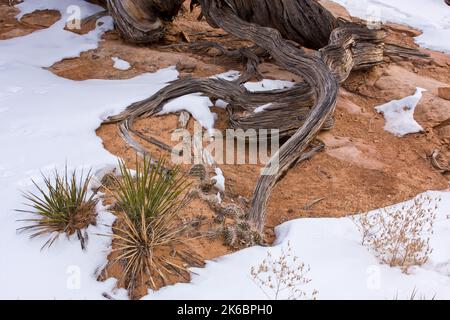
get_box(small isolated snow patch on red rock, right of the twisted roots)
[375,88,426,137]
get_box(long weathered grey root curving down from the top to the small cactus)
[202,1,383,231]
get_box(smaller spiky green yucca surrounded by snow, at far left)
[17,167,98,249]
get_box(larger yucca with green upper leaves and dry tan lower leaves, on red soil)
[111,158,193,291]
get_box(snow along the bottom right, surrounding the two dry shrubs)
[145,192,450,300]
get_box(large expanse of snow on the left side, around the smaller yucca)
[0,0,178,299]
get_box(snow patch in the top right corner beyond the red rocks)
[334,0,450,53]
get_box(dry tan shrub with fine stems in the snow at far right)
[354,195,440,273]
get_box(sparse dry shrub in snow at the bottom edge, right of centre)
[250,243,318,300]
